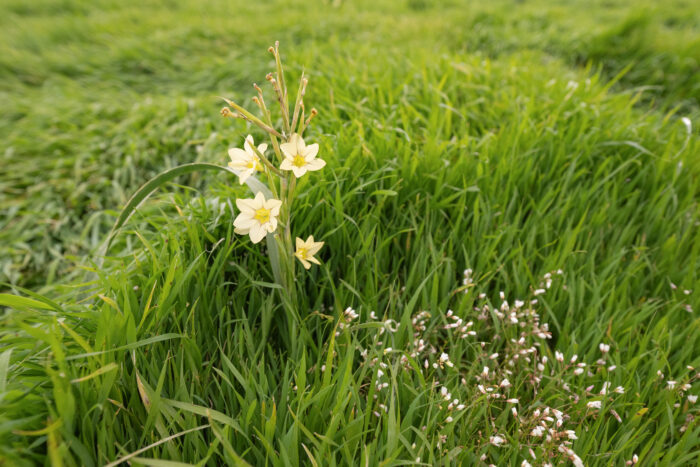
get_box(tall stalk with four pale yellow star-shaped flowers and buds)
[221,43,326,289]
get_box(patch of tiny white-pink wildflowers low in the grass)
[328,270,672,466]
